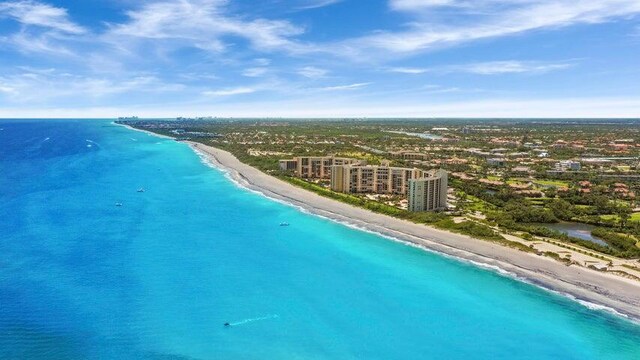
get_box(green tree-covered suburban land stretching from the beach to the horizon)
[122,119,640,258]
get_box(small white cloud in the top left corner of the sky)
[0,0,86,34]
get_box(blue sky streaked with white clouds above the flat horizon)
[0,0,640,117]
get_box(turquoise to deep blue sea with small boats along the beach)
[0,121,640,359]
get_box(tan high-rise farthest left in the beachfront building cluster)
[280,156,366,179]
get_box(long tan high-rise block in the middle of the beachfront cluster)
[331,164,424,195]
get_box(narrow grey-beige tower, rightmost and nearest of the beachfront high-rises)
[407,170,448,211]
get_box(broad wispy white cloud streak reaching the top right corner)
[344,0,640,56]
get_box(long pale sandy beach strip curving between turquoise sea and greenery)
[187,142,640,320]
